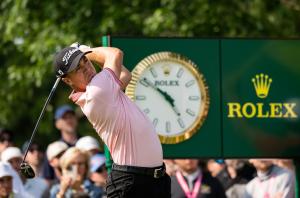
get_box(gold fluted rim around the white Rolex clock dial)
[126,51,210,144]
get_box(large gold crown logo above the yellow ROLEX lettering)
[252,74,272,98]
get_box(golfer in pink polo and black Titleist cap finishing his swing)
[54,44,171,198]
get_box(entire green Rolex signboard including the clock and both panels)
[111,38,300,158]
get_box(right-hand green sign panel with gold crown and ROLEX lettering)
[221,39,300,157]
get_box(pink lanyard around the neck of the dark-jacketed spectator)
[176,171,202,198]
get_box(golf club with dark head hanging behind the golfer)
[20,77,61,178]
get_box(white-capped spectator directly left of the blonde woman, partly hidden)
[46,141,68,186]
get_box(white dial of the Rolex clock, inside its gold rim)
[135,61,202,136]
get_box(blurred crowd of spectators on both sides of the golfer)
[0,105,296,198]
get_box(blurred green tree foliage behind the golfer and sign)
[0,0,300,145]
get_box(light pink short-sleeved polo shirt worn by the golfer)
[70,68,163,167]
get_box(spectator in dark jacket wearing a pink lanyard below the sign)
[171,159,226,198]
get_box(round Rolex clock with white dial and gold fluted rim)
[126,52,209,144]
